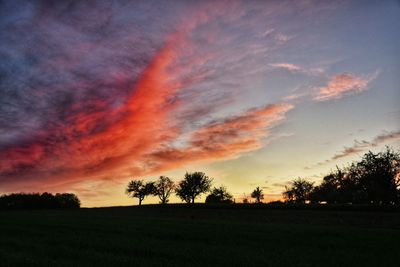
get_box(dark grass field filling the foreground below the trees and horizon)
[0,205,400,267]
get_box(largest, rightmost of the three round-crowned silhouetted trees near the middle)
[175,172,212,203]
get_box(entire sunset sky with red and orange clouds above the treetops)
[0,0,400,207]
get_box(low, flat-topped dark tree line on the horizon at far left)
[0,192,81,209]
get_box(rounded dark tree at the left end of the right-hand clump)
[283,178,314,203]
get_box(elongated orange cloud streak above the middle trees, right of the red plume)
[148,104,293,171]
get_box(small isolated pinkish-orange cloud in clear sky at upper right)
[313,72,378,101]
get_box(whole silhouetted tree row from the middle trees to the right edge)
[126,147,400,205]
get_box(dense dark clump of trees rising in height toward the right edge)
[283,147,400,205]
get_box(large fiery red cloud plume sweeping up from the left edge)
[0,46,179,189]
